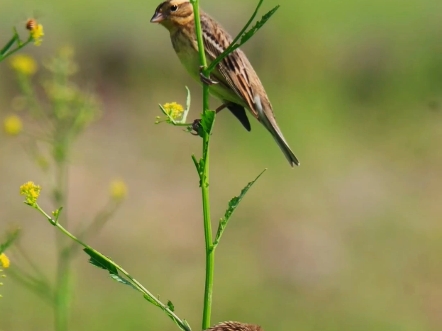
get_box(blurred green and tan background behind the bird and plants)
[0,0,442,331]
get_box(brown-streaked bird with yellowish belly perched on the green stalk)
[150,0,299,167]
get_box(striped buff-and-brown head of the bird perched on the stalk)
[150,0,193,30]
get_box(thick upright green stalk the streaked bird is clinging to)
[191,0,215,330]
